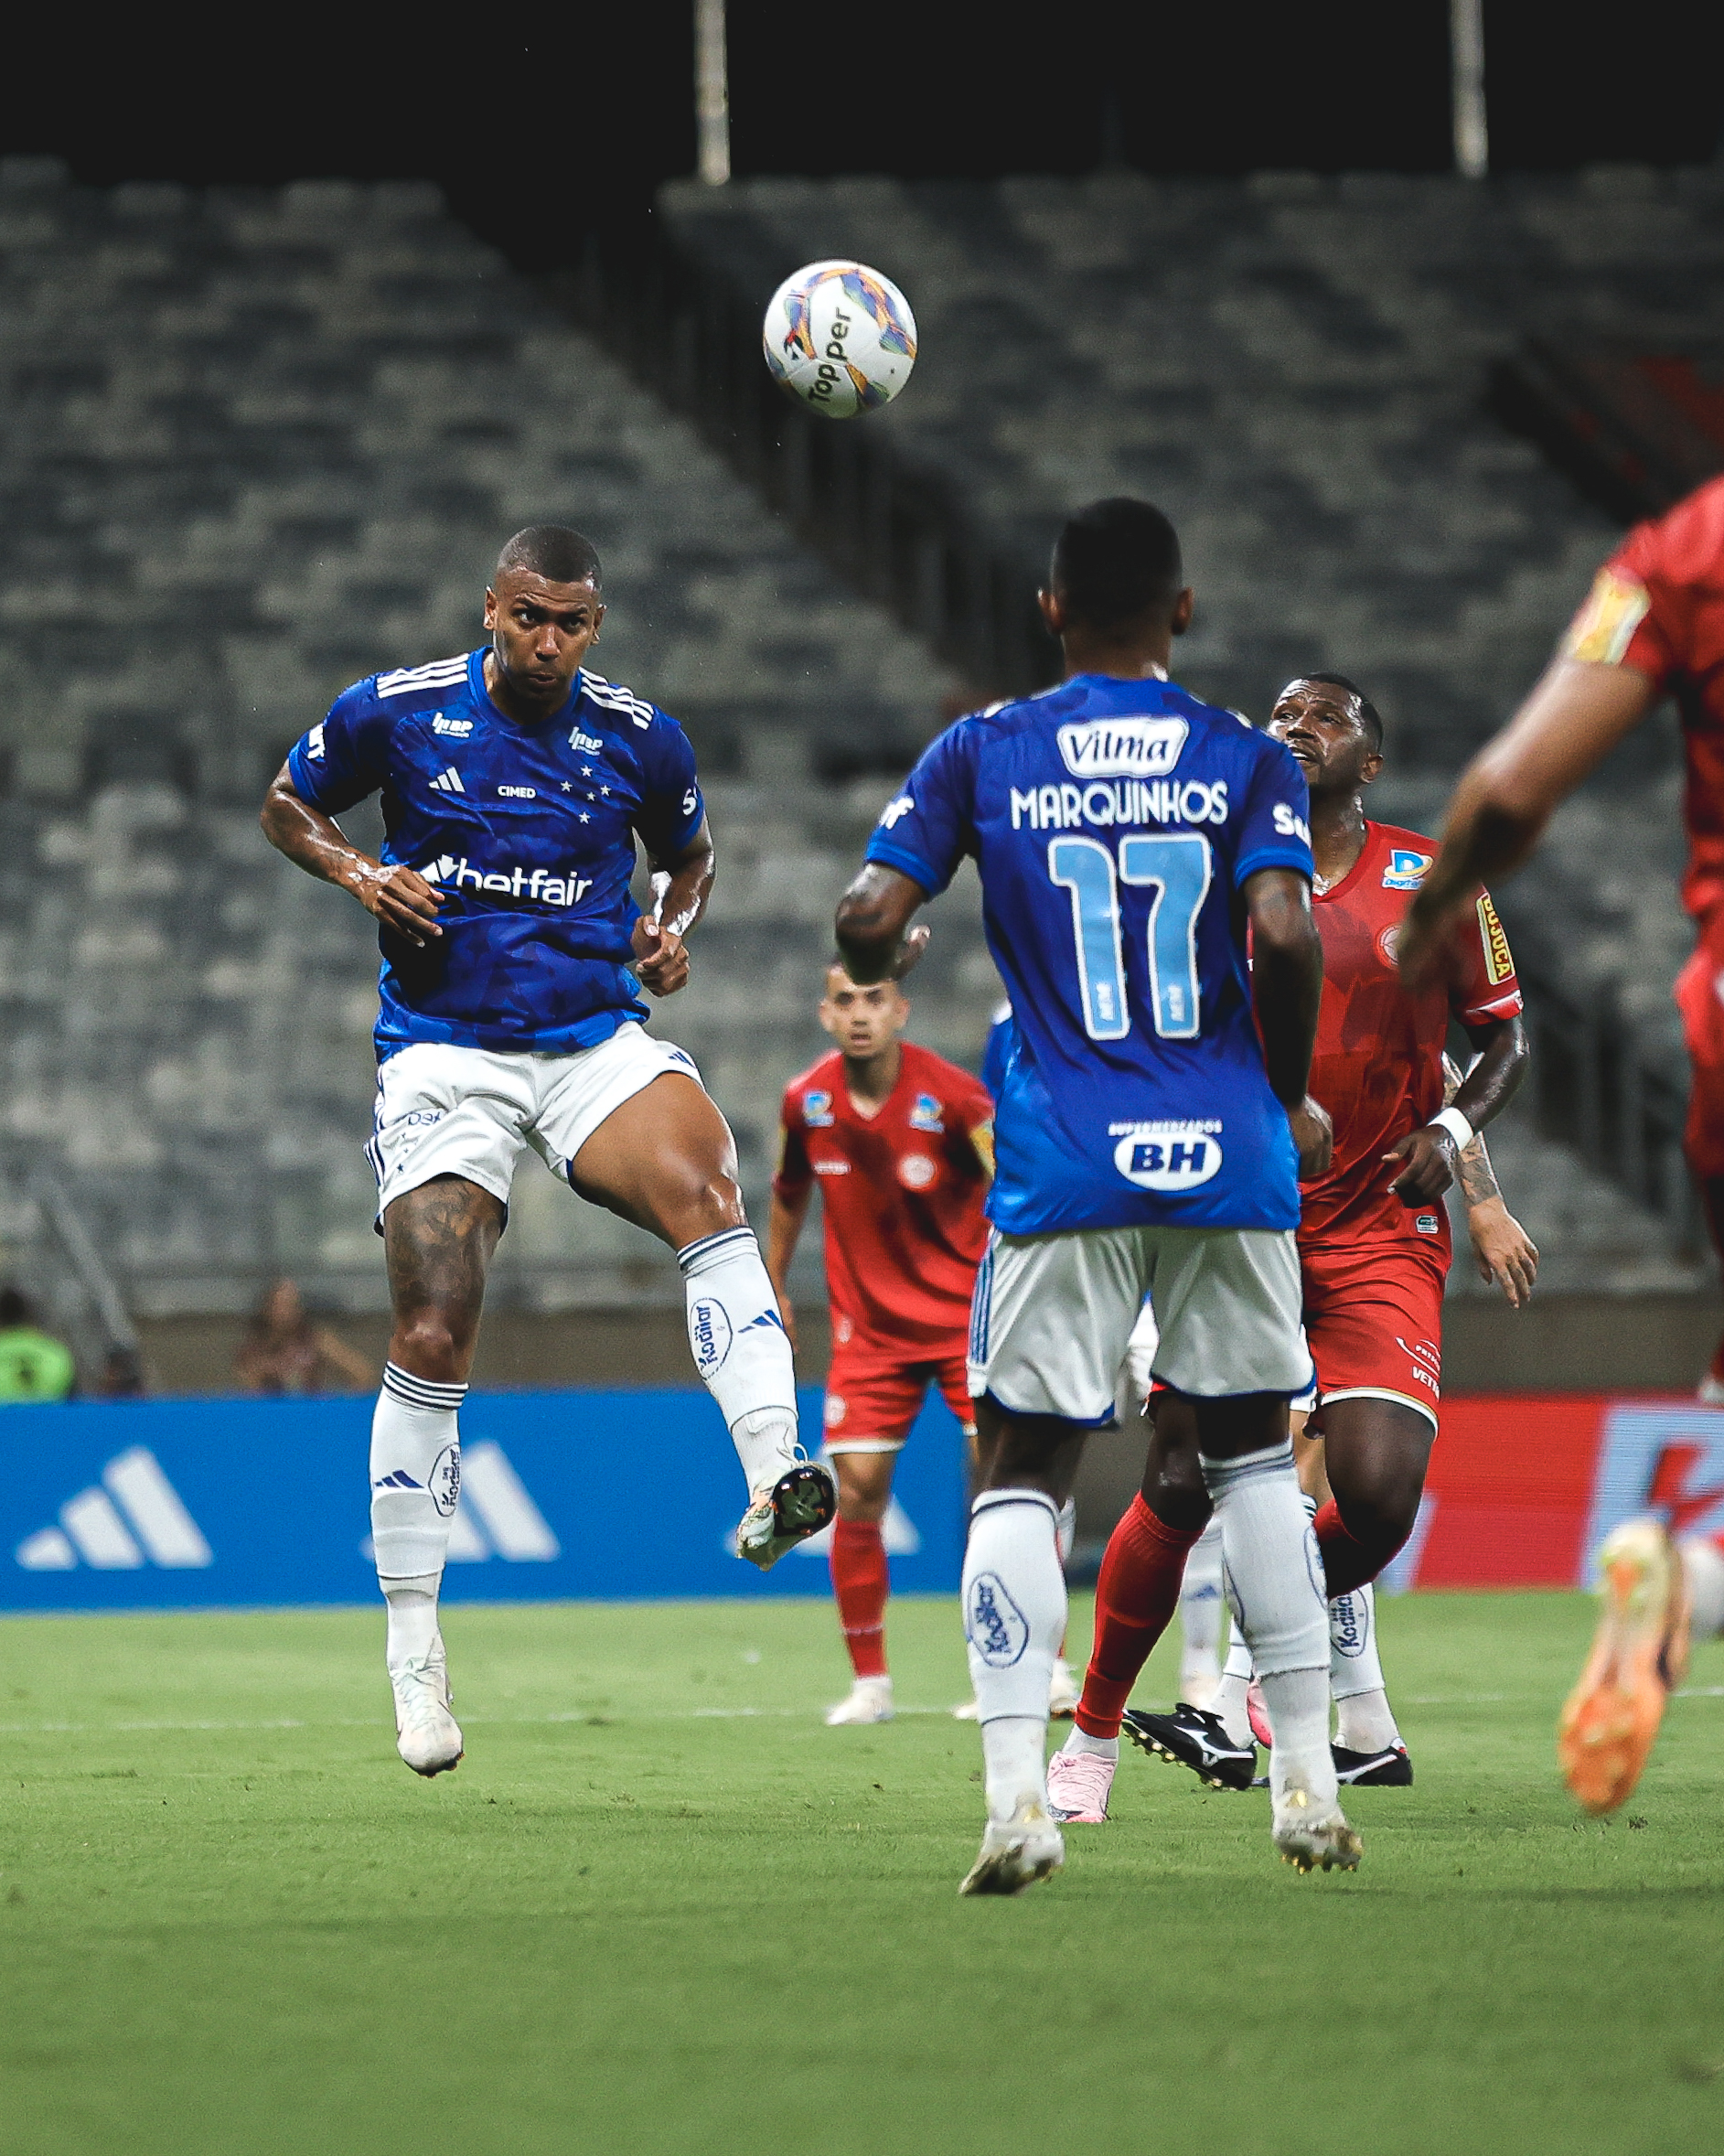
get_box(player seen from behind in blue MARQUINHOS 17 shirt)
[839,500,1360,1893]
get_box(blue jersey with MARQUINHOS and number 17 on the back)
[869,675,1312,1236]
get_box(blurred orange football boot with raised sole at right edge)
[1556,1520,1687,1818]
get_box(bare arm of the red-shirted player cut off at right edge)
[1398,660,1655,990]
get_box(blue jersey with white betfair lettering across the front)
[286,649,704,1061]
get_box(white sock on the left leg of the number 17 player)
[963,1490,1066,1819]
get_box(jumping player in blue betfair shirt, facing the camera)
[262,524,839,1775]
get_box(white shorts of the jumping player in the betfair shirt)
[364,1020,701,1220]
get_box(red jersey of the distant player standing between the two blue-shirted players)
[772,1041,993,1347]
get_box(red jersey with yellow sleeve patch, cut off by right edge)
[1562,478,1724,920]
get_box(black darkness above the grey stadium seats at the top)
[0,0,1724,265]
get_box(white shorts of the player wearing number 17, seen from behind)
[969,1227,1314,1430]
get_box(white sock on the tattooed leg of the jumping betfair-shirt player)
[370,1363,467,1667]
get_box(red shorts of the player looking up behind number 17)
[1300,1242,1444,1425]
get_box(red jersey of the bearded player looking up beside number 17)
[1300,823,1522,1263]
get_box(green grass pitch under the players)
[0,1595,1724,2156]
